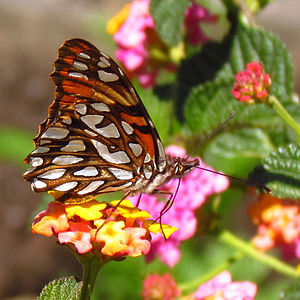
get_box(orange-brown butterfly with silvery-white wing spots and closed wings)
[23,39,200,203]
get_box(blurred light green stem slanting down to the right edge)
[219,230,300,278]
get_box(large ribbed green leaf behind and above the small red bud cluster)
[218,24,294,101]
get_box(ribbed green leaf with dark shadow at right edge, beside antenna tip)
[250,144,300,199]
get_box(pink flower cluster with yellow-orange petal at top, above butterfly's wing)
[108,0,161,88]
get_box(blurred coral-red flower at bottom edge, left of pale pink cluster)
[143,273,180,300]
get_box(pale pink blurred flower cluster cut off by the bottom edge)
[194,271,257,300]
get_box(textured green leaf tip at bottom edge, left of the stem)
[37,276,82,300]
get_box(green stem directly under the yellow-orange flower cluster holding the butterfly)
[80,260,101,300]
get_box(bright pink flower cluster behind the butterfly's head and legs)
[128,146,229,267]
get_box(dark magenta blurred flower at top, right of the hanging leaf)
[184,2,219,46]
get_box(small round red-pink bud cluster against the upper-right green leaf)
[232,61,271,104]
